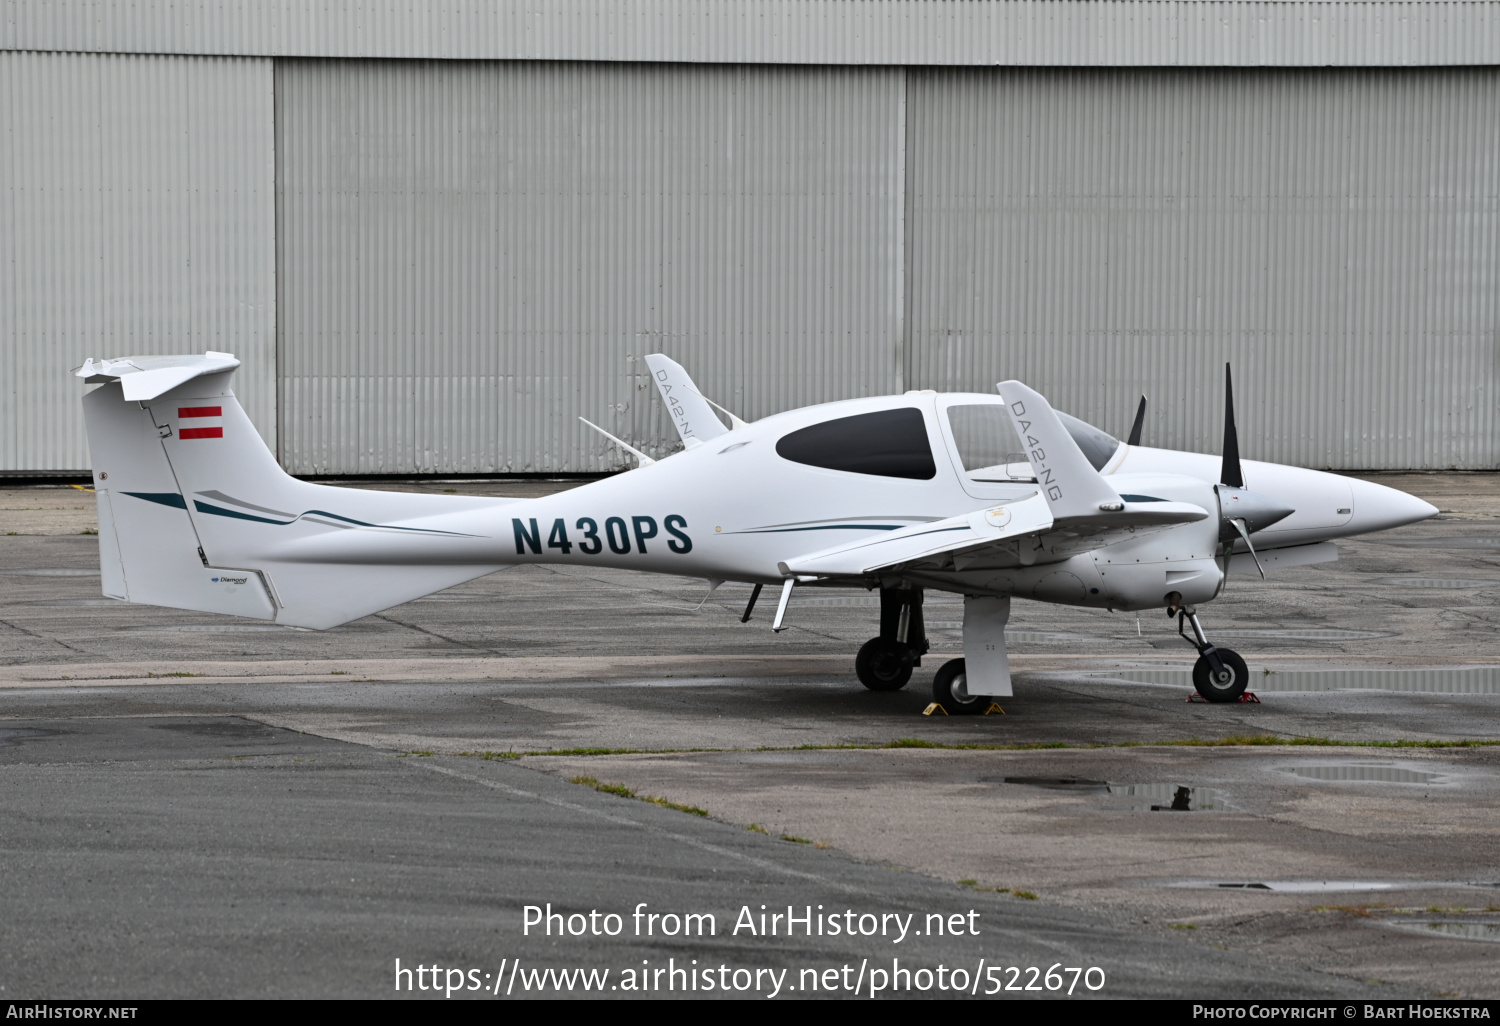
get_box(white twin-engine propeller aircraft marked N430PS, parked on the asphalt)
[78,353,1437,713]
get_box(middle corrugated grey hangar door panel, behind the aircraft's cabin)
[276,62,905,474]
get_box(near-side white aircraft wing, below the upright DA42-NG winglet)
[782,494,1209,578]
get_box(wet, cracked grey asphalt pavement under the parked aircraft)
[0,476,1500,999]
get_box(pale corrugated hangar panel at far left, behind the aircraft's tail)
[0,53,276,473]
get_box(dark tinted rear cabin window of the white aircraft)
[776,407,938,482]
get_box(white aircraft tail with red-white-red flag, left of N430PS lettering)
[78,353,515,630]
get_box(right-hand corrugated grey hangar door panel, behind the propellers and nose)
[906,69,1500,468]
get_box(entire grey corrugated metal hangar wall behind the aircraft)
[0,0,1500,474]
